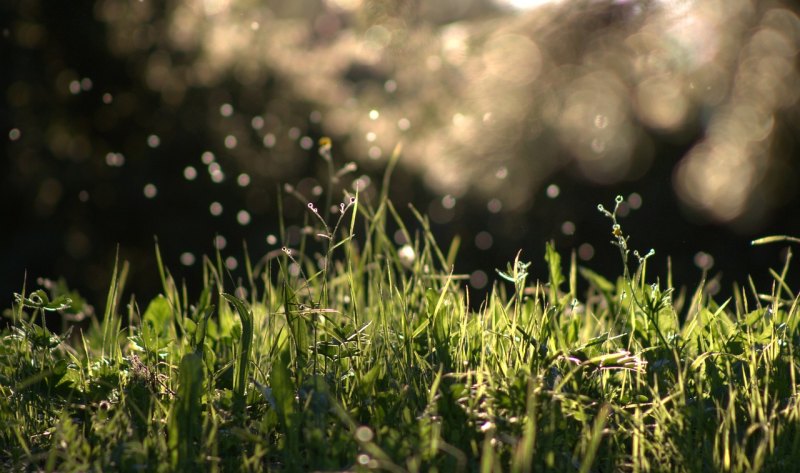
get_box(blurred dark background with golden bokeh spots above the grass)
[0,0,800,307]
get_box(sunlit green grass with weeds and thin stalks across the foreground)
[0,145,800,473]
